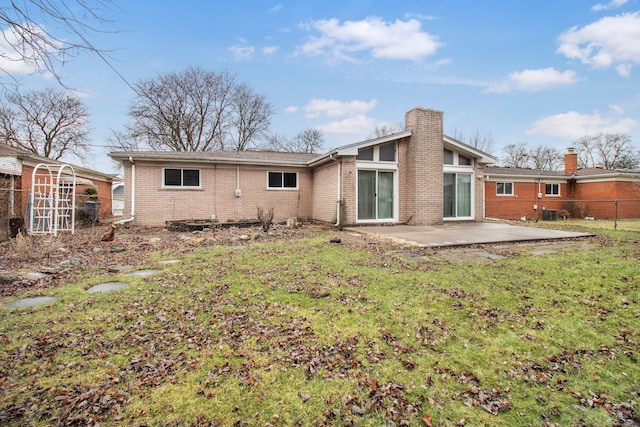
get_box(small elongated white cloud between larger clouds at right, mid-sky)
[487,68,577,93]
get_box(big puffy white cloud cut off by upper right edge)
[558,12,640,77]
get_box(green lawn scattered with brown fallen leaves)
[0,221,640,426]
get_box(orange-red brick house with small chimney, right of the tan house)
[485,148,640,220]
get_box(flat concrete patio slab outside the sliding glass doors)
[348,222,593,247]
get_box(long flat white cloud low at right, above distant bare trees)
[527,111,640,139]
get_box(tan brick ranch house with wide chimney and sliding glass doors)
[109,107,495,226]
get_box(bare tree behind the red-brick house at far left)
[0,89,90,160]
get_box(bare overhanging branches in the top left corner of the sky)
[0,0,114,86]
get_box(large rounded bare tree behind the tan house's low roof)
[126,67,273,151]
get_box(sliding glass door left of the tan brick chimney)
[358,170,394,220]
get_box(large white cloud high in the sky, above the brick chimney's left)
[297,17,443,61]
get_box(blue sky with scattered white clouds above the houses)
[0,0,640,173]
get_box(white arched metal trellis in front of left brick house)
[28,163,76,236]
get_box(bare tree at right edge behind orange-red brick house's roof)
[574,133,640,170]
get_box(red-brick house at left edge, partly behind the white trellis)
[0,144,113,240]
